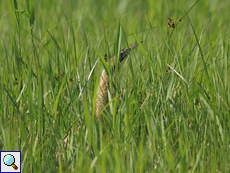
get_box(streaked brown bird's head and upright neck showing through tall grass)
[95,44,141,118]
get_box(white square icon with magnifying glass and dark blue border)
[0,151,21,173]
